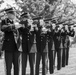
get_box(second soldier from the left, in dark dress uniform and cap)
[19,13,36,75]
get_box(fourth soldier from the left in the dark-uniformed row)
[47,23,56,74]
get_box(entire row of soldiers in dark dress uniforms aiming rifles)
[1,9,75,75]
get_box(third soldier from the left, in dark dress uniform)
[35,19,48,75]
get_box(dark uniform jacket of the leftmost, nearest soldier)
[1,18,18,51]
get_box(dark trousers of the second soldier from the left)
[22,52,35,75]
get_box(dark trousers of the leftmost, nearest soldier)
[5,51,20,75]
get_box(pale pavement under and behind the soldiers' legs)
[0,48,76,75]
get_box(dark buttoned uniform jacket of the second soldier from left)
[19,22,37,53]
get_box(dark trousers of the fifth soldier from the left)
[54,48,61,70]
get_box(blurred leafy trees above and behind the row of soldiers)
[0,0,76,44]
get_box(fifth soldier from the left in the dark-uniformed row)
[54,23,61,70]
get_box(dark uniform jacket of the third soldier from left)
[36,30,48,53]
